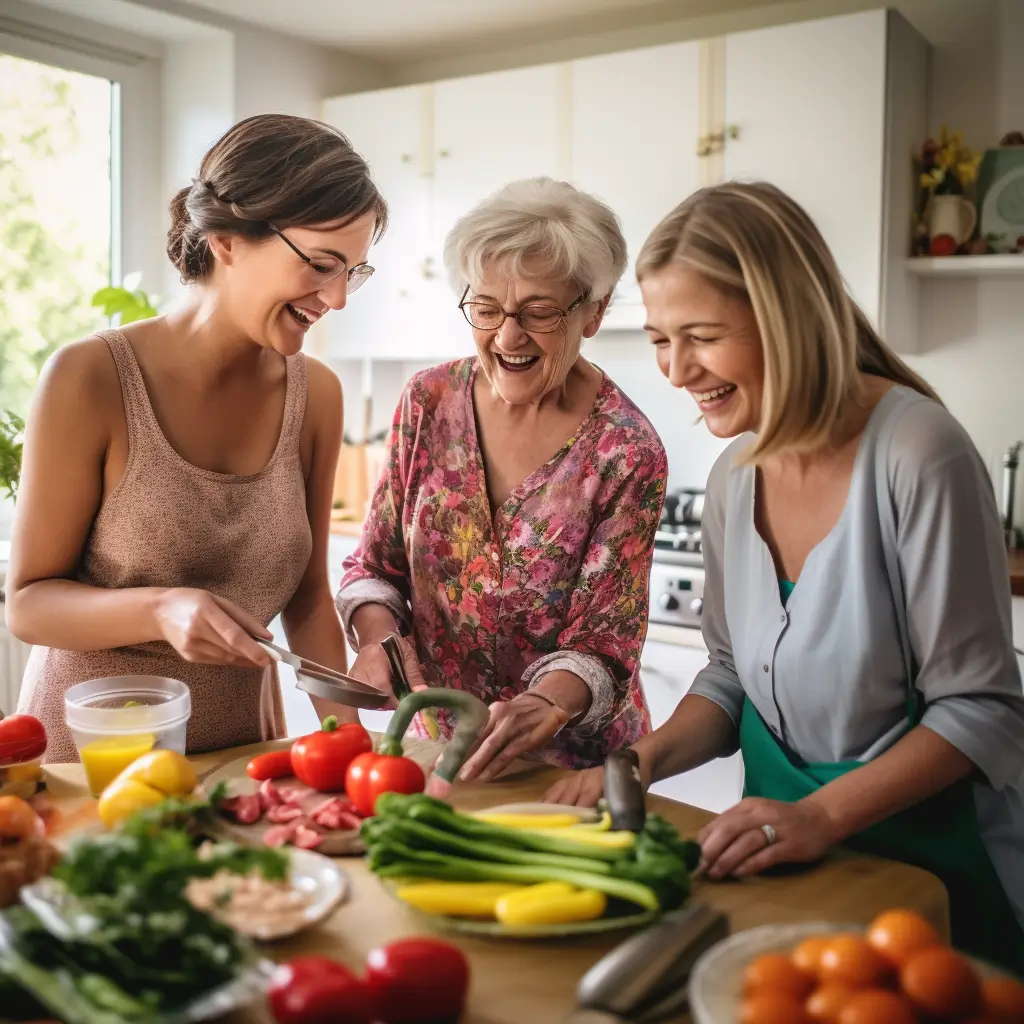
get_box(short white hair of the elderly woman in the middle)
[444,178,627,299]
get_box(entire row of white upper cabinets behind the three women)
[322,10,928,361]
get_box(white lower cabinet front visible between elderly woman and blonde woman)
[640,640,743,813]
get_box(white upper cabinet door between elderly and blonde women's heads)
[571,42,700,329]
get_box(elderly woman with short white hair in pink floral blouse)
[337,178,667,778]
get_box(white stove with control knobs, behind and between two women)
[650,487,705,629]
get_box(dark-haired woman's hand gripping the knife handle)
[156,587,273,669]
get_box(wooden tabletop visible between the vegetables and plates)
[41,744,949,1024]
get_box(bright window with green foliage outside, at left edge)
[0,54,116,416]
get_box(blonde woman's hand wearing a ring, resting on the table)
[697,797,837,880]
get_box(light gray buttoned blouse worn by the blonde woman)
[690,387,1024,927]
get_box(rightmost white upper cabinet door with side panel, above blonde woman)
[723,10,928,350]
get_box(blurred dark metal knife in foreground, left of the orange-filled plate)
[573,903,729,1024]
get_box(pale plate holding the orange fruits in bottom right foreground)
[689,921,1001,1024]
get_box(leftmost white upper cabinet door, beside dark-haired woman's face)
[323,86,431,358]
